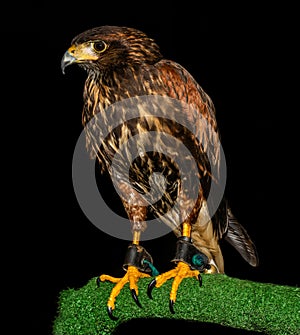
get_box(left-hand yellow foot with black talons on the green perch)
[97,266,150,320]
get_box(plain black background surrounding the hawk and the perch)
[1,1,299,334]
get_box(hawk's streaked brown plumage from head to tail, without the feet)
[62,26,258,315]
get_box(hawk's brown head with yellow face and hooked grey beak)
[61,26,162,73]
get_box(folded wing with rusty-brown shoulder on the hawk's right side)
[156,60,228,238]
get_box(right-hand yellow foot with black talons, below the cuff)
[147,262,202,314]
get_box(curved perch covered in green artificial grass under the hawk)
[53,274,300,335]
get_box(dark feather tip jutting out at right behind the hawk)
[224,208,258,266]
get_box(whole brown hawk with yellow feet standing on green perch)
[61,26,258,319]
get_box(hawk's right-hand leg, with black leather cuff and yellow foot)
[148,223,210,314]
